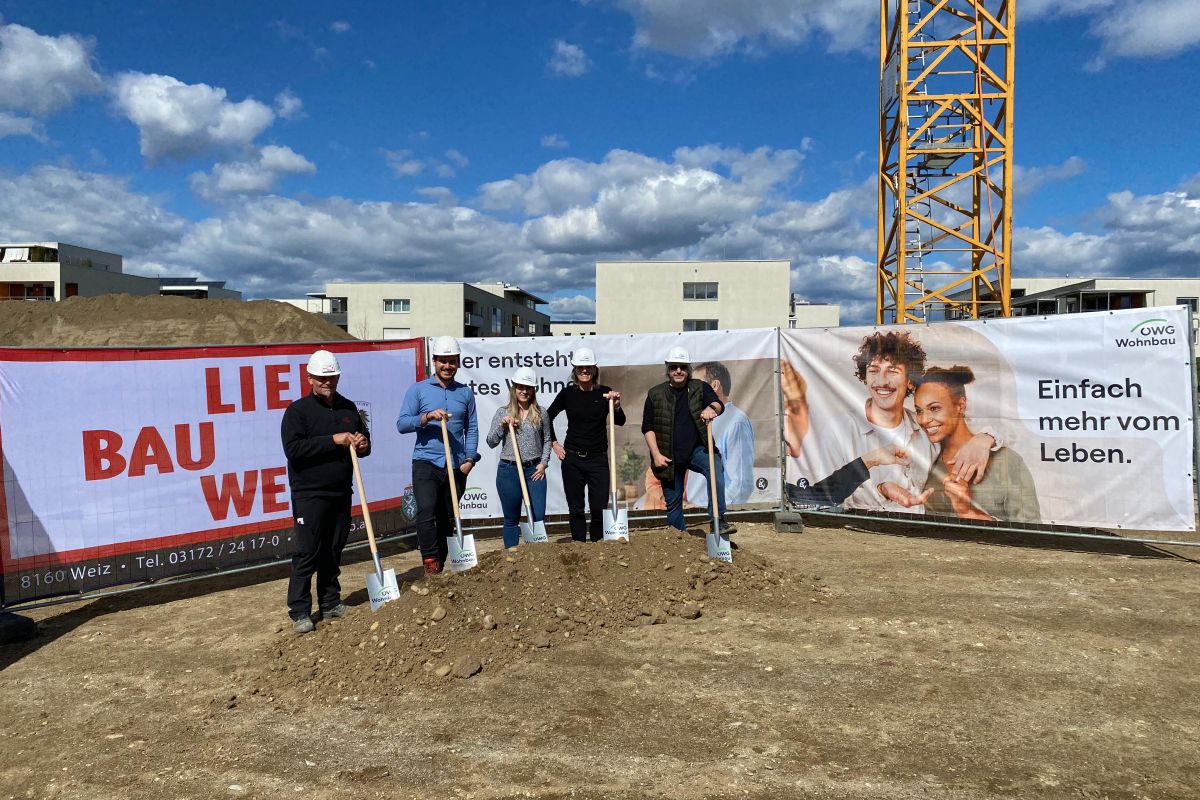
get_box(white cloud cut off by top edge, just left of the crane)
[618,0,880,59]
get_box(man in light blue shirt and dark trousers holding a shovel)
[396,336,479,575]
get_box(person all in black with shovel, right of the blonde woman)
[547,348,625,542]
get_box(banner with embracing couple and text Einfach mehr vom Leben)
[780,307,1195,531]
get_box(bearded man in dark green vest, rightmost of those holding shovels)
[642,347,737,536]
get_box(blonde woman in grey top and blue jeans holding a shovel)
[487,367,551,547]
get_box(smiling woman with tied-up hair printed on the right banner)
[913,365,1042,522]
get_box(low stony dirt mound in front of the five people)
[254,529,817,699]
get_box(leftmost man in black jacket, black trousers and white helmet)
[281,350,371,633]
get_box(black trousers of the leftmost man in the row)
[288,494,350,620]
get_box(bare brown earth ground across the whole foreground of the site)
[0,524,1200,799]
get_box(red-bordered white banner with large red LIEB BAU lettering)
[0,339,422,603]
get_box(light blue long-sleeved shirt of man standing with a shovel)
[396,377,479,469]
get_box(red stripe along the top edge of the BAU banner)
[0,339,425,362]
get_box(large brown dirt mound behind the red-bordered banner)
[0,294,354,347]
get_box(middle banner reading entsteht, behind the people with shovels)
[457,327,780,518]
